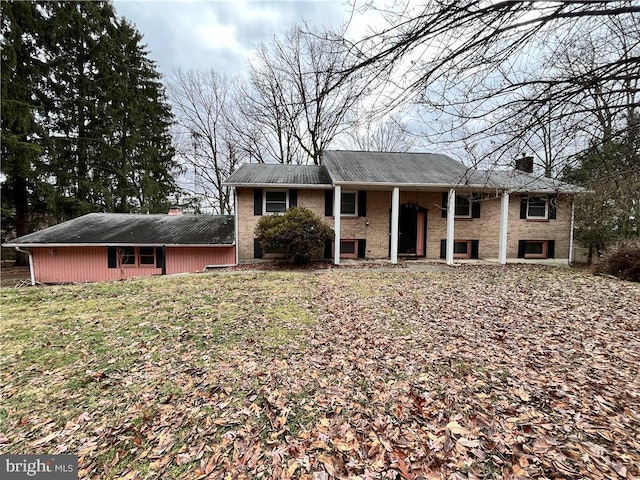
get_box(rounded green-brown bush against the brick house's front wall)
[255,207,334,264]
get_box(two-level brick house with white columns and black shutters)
[226,151,584,264]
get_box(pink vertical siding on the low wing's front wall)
[30,246,235,283]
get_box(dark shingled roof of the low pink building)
[5,213,235,247]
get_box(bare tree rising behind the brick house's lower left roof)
[242,28,362,165]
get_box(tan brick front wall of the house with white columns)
[236,188,572,263]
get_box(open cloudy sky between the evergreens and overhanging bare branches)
[113,0,372,75]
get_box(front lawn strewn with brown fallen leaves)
[0,266,640,479]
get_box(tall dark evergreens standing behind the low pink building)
[2,1,178,248]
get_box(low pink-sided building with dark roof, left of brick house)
[3,209,236,284]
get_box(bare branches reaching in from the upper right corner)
[336,0,640,169]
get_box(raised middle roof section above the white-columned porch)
[322,150,468,186]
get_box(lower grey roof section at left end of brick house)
[224,163,331,188]
